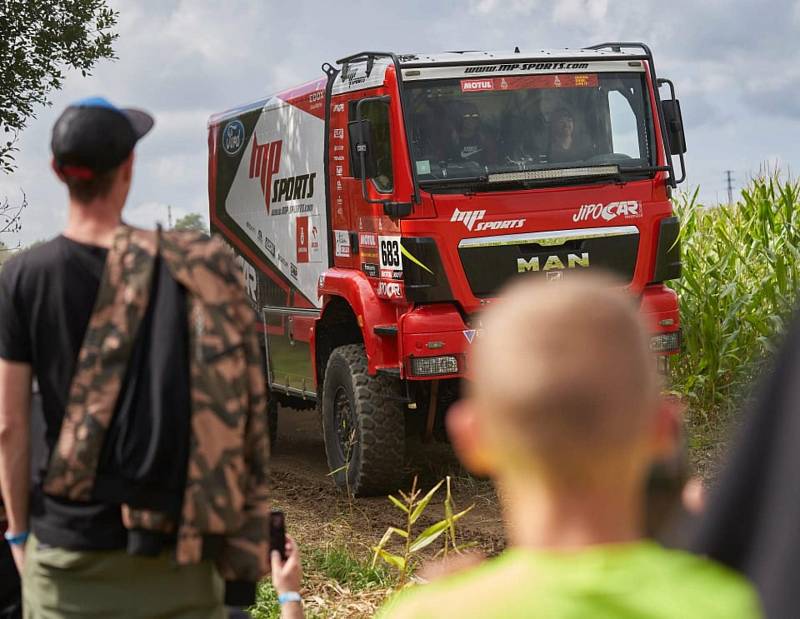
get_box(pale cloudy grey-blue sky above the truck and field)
[0,0,800,245]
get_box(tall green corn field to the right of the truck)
[673,175,800,427]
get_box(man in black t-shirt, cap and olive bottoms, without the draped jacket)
[0,98,224,617]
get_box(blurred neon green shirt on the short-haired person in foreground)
[380,541,761,619]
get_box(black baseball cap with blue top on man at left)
[50,97,155,180]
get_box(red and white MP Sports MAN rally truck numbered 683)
[208,43,686,495]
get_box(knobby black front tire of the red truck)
[322,344,405,496]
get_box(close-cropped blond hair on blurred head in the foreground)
[470,274,659,483]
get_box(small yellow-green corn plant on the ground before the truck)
[372,477,475,587]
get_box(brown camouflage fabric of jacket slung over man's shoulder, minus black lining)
[44,225,269,582]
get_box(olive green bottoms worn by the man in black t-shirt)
[22,536,226,619]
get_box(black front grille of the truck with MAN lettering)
[458,226,639,297]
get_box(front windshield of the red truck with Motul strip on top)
[406,72,655,184]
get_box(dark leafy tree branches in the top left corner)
[0,0,118,172]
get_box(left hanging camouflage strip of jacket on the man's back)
[44,225,159,501]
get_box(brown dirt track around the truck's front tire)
[272,409,504,554]
